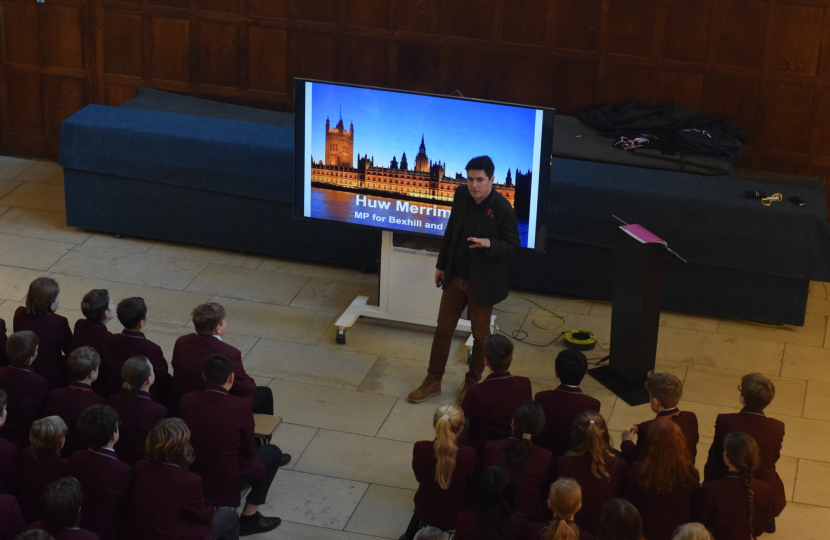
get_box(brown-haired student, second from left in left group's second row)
[43,346,106,458]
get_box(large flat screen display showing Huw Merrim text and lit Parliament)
[295,80,554,250]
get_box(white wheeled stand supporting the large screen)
[334,231,496,356]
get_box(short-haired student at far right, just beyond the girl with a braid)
[703,373,787,533]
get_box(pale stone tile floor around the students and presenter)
[0,157,830,540]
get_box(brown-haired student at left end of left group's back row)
[14,278,72,388]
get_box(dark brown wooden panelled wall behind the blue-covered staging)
[0,0,830,181]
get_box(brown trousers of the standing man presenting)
[427,277,493,383]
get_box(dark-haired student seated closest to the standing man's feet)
[461,334,533,452]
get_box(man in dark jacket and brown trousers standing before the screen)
[409,156,521,403]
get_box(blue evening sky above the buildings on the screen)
[311,83,536,183]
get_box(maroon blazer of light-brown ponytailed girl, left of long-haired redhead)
[556,454,628,535]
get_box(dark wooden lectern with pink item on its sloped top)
[588,225,667,406]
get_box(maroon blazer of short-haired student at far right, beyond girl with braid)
[703,409,787,515]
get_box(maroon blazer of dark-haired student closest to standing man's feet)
[461,371,533,453]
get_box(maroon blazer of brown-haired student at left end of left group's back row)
[14,306,72,388]
